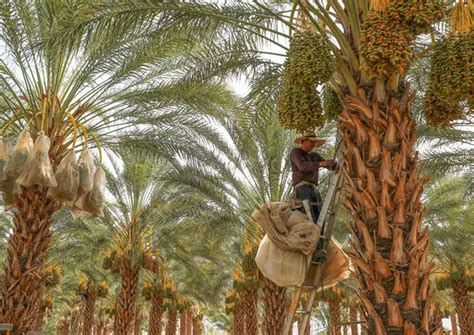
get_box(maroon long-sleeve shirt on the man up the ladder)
[290,148,324,186]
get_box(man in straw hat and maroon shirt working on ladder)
[290,131,336,222]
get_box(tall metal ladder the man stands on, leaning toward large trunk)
[282,171,343,335]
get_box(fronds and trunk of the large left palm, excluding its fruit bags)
[0,0,237,333]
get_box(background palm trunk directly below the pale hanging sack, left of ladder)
[262,278,290,335]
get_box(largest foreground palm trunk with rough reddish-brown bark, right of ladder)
[339,82,434,335]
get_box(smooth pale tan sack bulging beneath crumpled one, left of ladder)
[255,235,308,287]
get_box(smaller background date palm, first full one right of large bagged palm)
[104,151,171,334]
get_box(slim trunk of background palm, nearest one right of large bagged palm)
[114,257,140,335]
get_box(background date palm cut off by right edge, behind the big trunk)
[426,174,474,334]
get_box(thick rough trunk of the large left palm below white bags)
[0,186,60,334]
